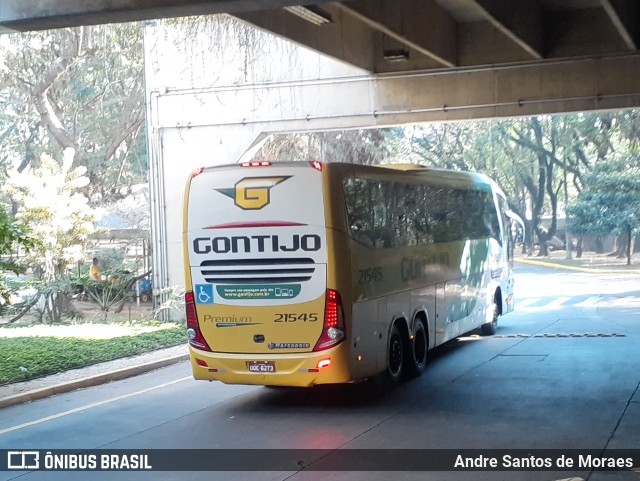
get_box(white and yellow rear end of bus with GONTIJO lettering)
[183,162,349,386]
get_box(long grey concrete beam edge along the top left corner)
[0,0,324,33]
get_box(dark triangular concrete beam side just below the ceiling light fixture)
[234,4,376,72]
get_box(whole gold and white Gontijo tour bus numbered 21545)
[183,161,522,386]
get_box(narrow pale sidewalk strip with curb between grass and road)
[0,343,189,409]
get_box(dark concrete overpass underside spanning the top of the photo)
[0,0,640,120]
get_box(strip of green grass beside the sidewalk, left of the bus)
[0,325,186,385]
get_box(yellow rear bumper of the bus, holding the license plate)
[189,342,351,387]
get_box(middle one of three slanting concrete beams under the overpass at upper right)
[476,0,544,60]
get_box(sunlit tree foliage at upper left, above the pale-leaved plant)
[0,24,147,200]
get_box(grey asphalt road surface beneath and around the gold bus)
[0,266,640,481]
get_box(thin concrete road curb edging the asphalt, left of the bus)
[0,354,189,409]
